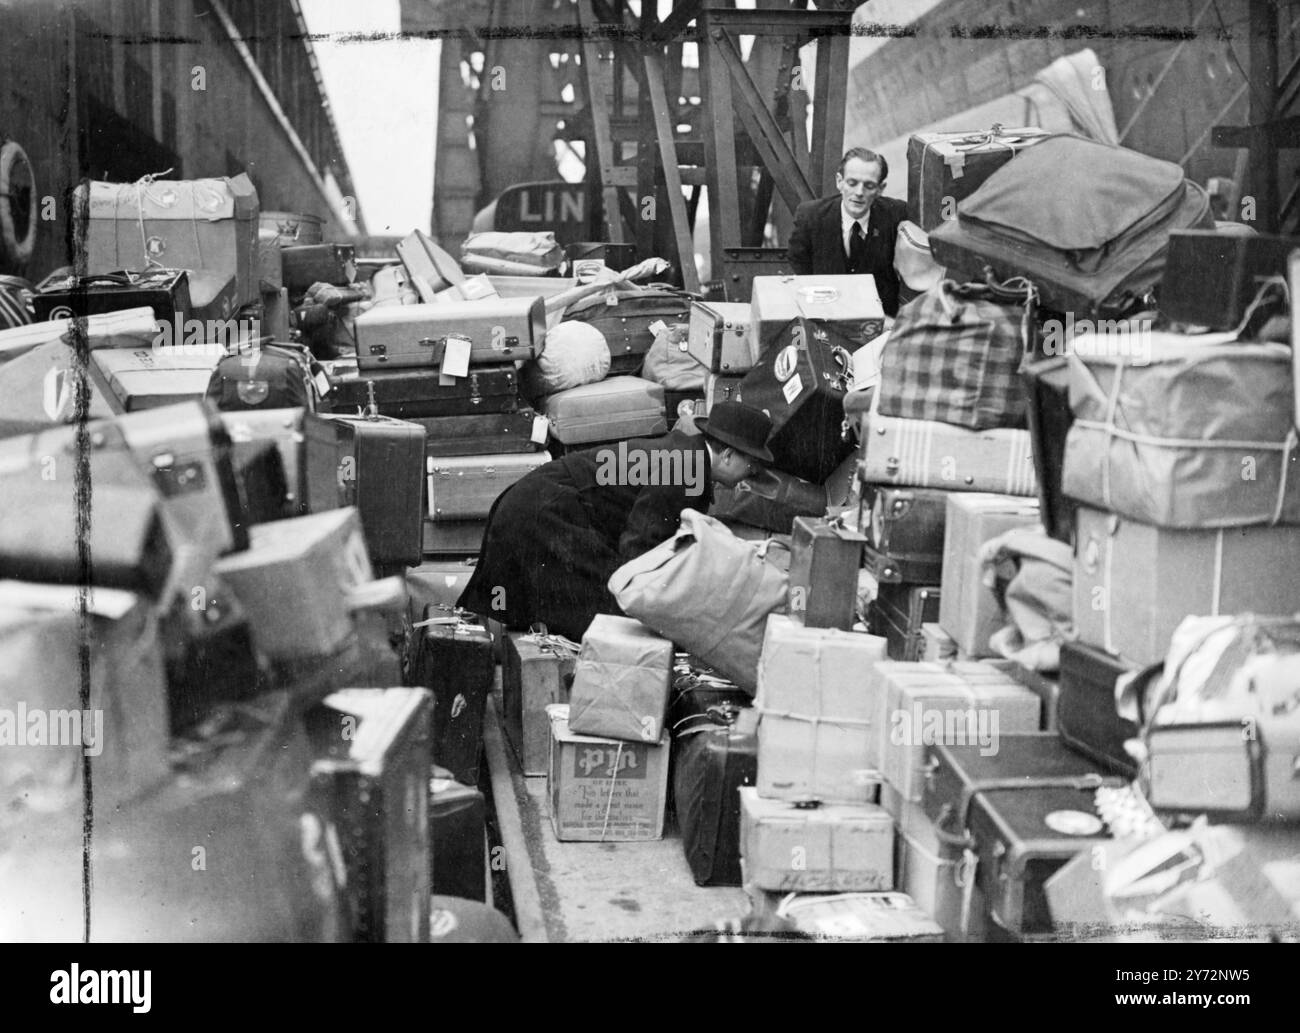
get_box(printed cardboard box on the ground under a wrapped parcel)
[546,703,668,843]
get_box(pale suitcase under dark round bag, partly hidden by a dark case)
[221,409,341,516]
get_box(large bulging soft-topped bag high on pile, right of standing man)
[930,134,1214,317]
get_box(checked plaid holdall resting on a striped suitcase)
[879,279,1034,430]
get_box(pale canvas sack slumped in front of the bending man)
[608,509,789,695]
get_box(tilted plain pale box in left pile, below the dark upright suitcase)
[215,507,373,660]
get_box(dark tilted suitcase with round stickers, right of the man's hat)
[736,320,855,485]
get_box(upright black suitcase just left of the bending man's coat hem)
[411,606,497,786]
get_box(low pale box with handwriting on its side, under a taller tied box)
[740,786,894,893]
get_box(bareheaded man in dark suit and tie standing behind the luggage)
[788,147,907,316]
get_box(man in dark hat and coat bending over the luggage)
[458,402,772,641]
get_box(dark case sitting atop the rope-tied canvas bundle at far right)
[1157,230,1300,330]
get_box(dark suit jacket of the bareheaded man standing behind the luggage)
[787,194,907,316]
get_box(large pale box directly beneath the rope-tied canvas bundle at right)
[1074,505,1300,667]
